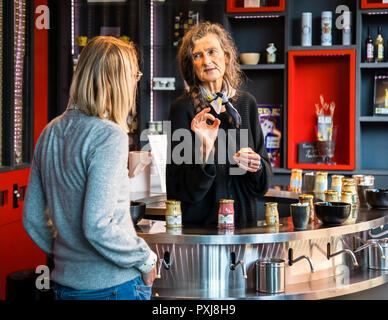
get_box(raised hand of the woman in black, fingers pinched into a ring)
[191,108,221,161]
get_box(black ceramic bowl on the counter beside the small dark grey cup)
[314,202,351,225]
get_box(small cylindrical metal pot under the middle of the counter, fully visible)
[256,258,286,294]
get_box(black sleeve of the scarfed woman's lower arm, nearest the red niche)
[242,95,272,197]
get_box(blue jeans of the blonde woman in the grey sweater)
[54,277,152,300]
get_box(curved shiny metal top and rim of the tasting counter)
[136,209,388,245]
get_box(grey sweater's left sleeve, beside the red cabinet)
[23,142,53,254]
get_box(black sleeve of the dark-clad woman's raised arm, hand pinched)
[166,98,216,203]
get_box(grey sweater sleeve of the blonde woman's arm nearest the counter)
[82,132,156,273]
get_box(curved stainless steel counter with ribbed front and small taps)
[132,190,388,300]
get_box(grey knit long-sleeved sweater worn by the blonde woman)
[23,110,156,290]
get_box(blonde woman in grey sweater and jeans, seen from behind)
[23,37,156,300]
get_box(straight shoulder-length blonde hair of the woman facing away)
[68,36,139,132]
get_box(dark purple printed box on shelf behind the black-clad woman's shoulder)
[257,104,282,168]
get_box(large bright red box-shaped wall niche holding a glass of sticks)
[288,50,356,170]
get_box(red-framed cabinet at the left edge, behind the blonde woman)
[0,0,48,300]
